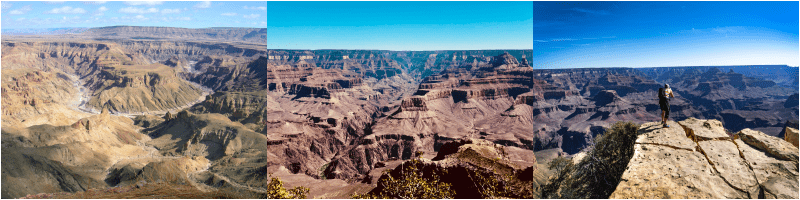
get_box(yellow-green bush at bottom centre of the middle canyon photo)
[352,159,455,199]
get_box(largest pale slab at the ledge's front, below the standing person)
[609,144,748,199]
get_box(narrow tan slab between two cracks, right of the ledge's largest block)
[698,140,758,195]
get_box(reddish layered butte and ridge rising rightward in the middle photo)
[316,54,533,178]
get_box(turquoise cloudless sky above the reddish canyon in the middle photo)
[267,2,533,50]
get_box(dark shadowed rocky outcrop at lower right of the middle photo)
[370,139,536,198]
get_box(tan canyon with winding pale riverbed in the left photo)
[2,27,267,198]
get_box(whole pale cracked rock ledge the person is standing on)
[610,118,798,199]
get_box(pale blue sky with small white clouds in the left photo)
[2,1,267,29]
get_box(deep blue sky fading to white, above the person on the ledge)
[532,2,799,68]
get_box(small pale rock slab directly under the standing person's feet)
[636,121,697,150]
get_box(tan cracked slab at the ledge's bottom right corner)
[736,139,800,199]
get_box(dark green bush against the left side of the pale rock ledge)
[542,122,639,199]
